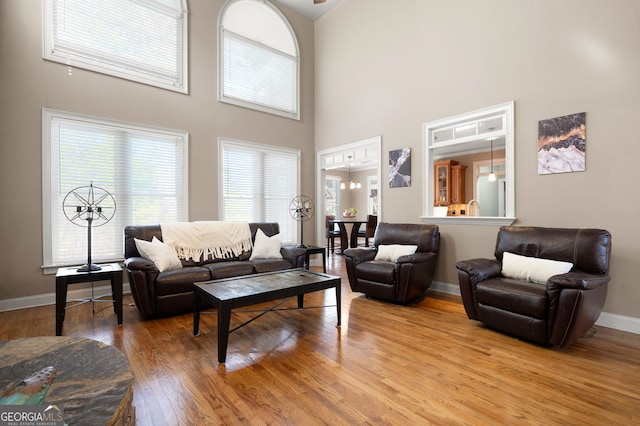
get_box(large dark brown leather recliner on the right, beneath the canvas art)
[456,226,611,347]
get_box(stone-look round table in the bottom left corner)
[0,336,135,425]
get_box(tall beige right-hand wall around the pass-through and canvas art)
[315,0,640,318]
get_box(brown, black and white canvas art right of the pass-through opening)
[538,112,587,175]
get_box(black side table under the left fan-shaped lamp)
[56,263,122,336]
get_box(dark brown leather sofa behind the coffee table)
[124,222,305,317]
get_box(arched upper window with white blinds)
[218,0,300,119]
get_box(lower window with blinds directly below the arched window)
[219,139,300,244]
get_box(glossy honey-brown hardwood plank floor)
[0,255,640,425]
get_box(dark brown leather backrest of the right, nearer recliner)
[494,226,611,274]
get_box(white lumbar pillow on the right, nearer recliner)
[502,252,573,284]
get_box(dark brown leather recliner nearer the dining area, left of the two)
[344,222,440,303]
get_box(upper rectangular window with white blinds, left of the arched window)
[42,0,188,93]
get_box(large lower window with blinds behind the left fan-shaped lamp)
[42,109,188,267]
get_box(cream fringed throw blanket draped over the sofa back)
[160,221,252,262]
